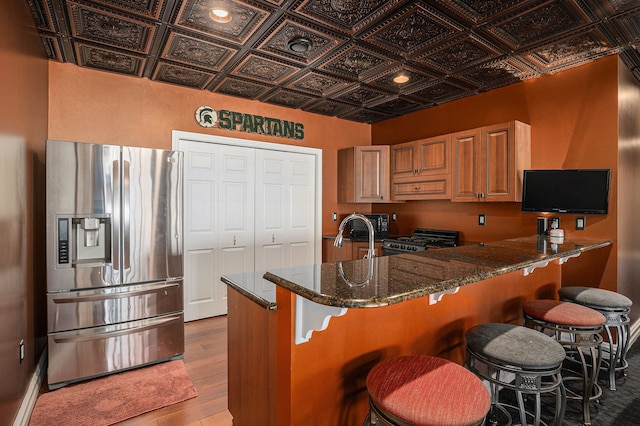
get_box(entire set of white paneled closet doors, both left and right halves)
[174,130,322,321]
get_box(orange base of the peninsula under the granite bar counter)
[228,260,564,426]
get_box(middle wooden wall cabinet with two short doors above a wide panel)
[390,135,451,201]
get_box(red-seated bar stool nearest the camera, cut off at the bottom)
[365,355,489,426]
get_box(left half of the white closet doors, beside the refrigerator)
[178,140,255,321]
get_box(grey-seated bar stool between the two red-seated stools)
[465,323,566,426]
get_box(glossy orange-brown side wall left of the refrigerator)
[0,1,47,425]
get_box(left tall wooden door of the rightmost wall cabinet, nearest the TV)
[451,129,481,201]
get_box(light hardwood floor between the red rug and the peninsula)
[118,316,232,426]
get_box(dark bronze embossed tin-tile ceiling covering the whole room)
[24,0,640,123]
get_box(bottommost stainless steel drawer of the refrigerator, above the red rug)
[47,313,184,389]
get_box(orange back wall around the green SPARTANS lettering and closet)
[49,62,371,236]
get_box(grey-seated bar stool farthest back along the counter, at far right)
[558,286,633,391]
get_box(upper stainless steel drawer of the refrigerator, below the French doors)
[47,280,184,333]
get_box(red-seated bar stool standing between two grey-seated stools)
[522,300,605,425]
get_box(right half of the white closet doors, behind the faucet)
[255,150,315,270]
